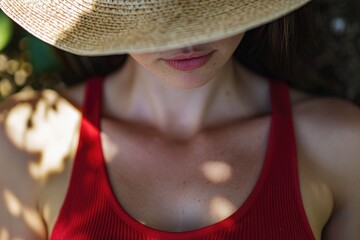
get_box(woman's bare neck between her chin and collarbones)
[107,58,258,138]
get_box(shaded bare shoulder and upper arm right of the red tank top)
[293,94,360,239]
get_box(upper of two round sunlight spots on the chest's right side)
[201,161,232,184]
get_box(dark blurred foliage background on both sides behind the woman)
[0,0,360,106]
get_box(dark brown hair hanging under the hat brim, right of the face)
[235,3,315,83]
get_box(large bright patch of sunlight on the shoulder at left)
[5,90,76,179]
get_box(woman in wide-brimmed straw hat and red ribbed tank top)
[0,0,360,240]
